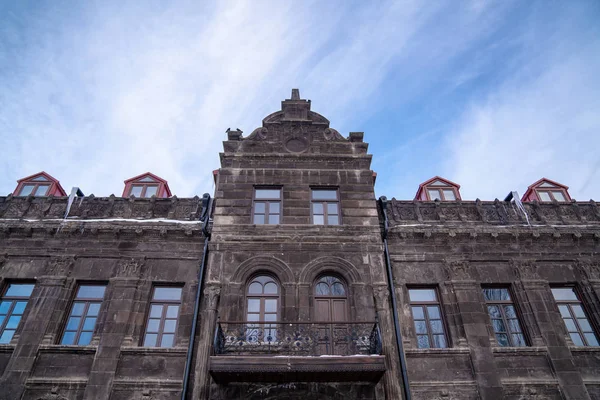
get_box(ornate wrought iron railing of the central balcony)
[214,321,381,356]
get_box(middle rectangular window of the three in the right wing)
[483,288,527,347]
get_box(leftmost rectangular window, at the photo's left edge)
[0,283,34,344]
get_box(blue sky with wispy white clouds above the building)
[0,0,600,201]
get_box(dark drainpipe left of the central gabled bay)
[181,193,212,400]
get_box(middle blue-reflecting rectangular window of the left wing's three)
[60,285,106,346]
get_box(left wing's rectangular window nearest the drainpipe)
[144,286,182,347]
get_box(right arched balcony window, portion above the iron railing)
[314,275,348,322]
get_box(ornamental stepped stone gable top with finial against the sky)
[227,89,354,153]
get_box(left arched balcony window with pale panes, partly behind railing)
[246,275,279,342]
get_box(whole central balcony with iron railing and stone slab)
[210,321,385,383]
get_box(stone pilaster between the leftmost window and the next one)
[0,276,67,400]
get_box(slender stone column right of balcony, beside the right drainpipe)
[373,284,403,399]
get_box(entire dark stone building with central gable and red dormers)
[0,90,600,400]
